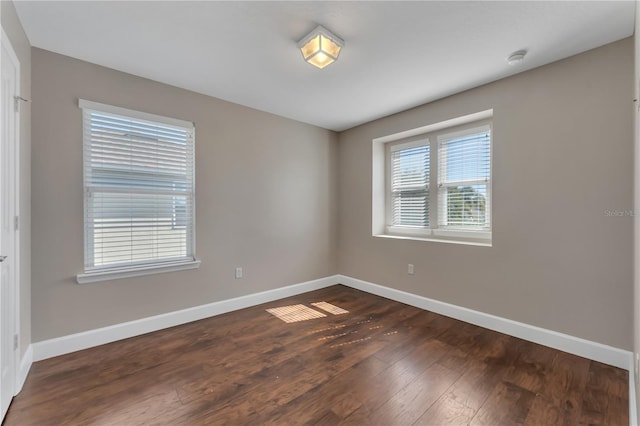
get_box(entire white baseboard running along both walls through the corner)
[31,275,633,371]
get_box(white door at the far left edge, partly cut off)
[0,31,20,418]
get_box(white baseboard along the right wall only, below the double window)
[339,275,633,370]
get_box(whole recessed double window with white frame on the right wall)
[373,111,492,245]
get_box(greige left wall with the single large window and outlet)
[32,48,337,342]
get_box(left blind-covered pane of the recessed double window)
[391,141,430,228]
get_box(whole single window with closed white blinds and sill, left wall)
[78,100,199,282]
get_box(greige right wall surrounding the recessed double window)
[338,38,633,350]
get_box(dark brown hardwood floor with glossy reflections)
[4,286,629,426]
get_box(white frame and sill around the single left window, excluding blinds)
[76,99,200,284]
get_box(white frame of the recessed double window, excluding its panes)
[372,110,493,246]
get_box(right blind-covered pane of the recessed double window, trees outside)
[438,126,491,230]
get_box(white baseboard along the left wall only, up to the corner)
[32,275,338,361]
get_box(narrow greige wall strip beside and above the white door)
[0,1,31,356]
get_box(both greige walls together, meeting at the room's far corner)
[32,33,633,349]
